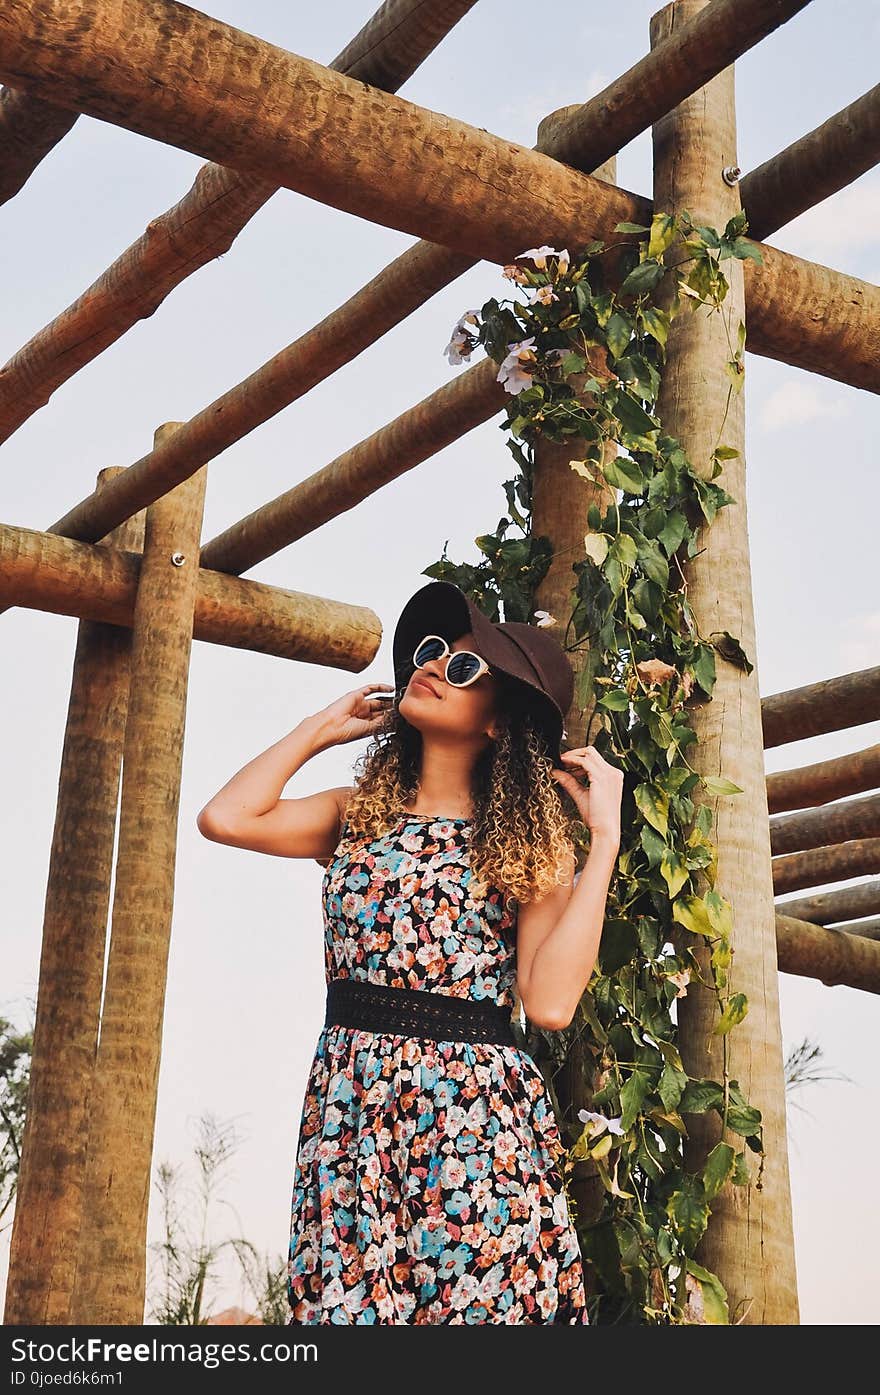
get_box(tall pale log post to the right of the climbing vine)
[650,0,799,1324]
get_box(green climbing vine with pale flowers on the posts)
[424,212,764,1324]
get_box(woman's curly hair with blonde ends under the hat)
[338,672,579,903]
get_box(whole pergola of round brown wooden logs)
[0,0,880,1324]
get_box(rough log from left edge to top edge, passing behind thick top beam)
[0,0,476,441]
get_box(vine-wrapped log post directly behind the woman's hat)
[531,106,616,1255]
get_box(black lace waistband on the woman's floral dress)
[324,978,516,1046]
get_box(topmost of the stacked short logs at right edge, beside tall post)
[761,665,880,751]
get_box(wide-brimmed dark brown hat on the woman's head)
[392,582,575,764]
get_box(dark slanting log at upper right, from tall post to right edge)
[739,85,880,239]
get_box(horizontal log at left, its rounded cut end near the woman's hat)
[0,525,382,672]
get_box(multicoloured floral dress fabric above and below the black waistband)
[287,813,589,1324]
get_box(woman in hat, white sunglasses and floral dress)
[198,582,623,1324]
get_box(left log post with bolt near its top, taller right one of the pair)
[71,423,206,1325]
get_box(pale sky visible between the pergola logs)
[0,0,880,1324]
